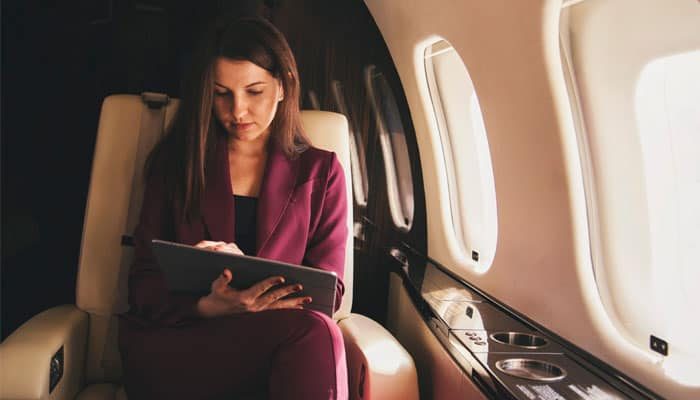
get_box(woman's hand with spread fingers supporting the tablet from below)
[197,269,311,318]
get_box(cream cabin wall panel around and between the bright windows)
[366,0,697,398]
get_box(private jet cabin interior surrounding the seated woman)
[0,0,700,400]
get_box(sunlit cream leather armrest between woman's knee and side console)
[338,314,419,400]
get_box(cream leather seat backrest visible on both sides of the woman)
[76,93,353,381]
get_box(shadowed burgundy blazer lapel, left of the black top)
[202,139,236,243]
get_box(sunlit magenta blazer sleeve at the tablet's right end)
[304,153,348,310]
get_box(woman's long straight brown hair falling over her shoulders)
[145,18,310,219]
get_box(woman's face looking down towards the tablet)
[214,57,284,141]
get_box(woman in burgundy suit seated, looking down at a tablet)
[119,19,347,400]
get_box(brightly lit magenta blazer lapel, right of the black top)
[256,140,299,255]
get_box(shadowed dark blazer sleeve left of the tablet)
[128,174,198,326]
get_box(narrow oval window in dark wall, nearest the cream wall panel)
[365,65,414,231]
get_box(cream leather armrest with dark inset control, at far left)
[0,305,88,399]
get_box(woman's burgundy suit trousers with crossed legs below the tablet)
[119,309,348,400]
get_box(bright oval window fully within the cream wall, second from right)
[425,40,498,271]
